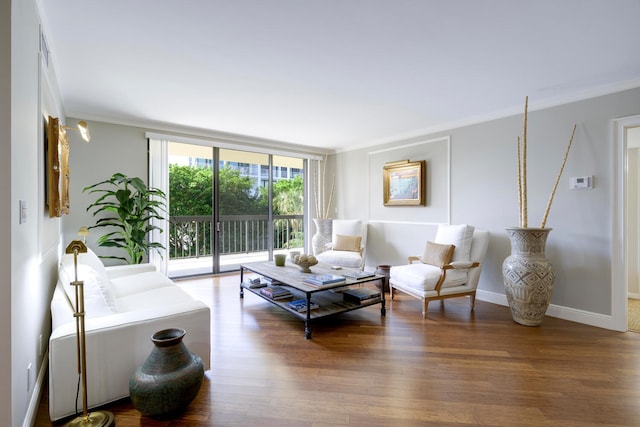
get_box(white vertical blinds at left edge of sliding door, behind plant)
[149,138,169,274]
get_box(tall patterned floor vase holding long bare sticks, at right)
[502,227,555,326]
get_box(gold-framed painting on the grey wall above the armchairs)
[382,160,427,206]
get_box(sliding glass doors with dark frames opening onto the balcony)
[168,142,305,277]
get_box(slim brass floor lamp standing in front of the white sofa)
[65,240,115,427]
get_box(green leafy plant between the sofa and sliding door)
[82,173,166,264]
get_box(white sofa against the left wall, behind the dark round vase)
[49,249,211,421]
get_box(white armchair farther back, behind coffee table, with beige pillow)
[316,219,367,269]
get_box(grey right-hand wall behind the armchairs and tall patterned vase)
[335,89,640,328]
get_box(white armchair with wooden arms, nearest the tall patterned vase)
[389,224,489,317]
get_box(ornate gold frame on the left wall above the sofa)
[45,116,69,218]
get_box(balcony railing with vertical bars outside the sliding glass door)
[169,215,304,259]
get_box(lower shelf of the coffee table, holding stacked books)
[241,284,384,320]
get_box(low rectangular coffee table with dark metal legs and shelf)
[240,260,386,339]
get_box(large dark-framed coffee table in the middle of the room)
[240,260,386,339]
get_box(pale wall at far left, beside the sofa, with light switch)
[0,0,65,426]
